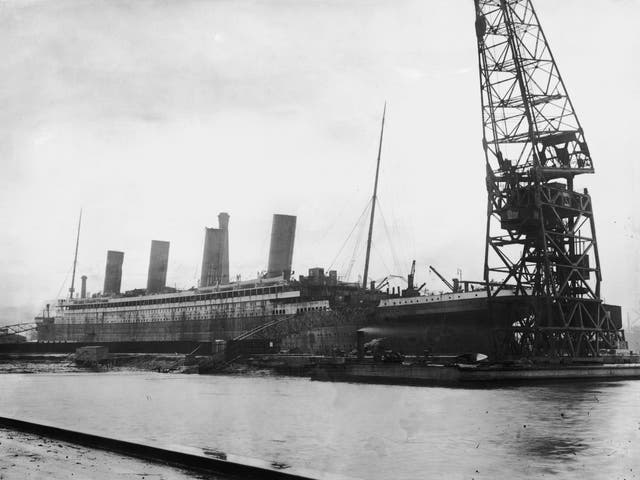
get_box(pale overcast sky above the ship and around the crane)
[0,0,640,323]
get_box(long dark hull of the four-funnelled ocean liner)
[38,291,621,357]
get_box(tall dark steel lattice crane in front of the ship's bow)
[474,0,624,357]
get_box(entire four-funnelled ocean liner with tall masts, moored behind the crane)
[31,82,622,358]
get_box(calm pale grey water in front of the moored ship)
[0,372,640,480]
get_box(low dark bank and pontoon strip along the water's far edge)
[5,354,640,388]
